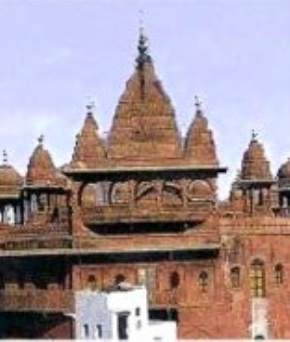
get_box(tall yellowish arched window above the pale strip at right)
[250,259,266,298]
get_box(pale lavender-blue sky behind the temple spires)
[0,0,290,198]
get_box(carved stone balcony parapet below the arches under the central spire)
[82,201,213,226]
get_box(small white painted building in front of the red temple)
[75,283,176,342]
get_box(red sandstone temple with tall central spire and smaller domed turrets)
[0,33,290,338]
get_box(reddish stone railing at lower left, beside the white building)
[0,289,74,313]
